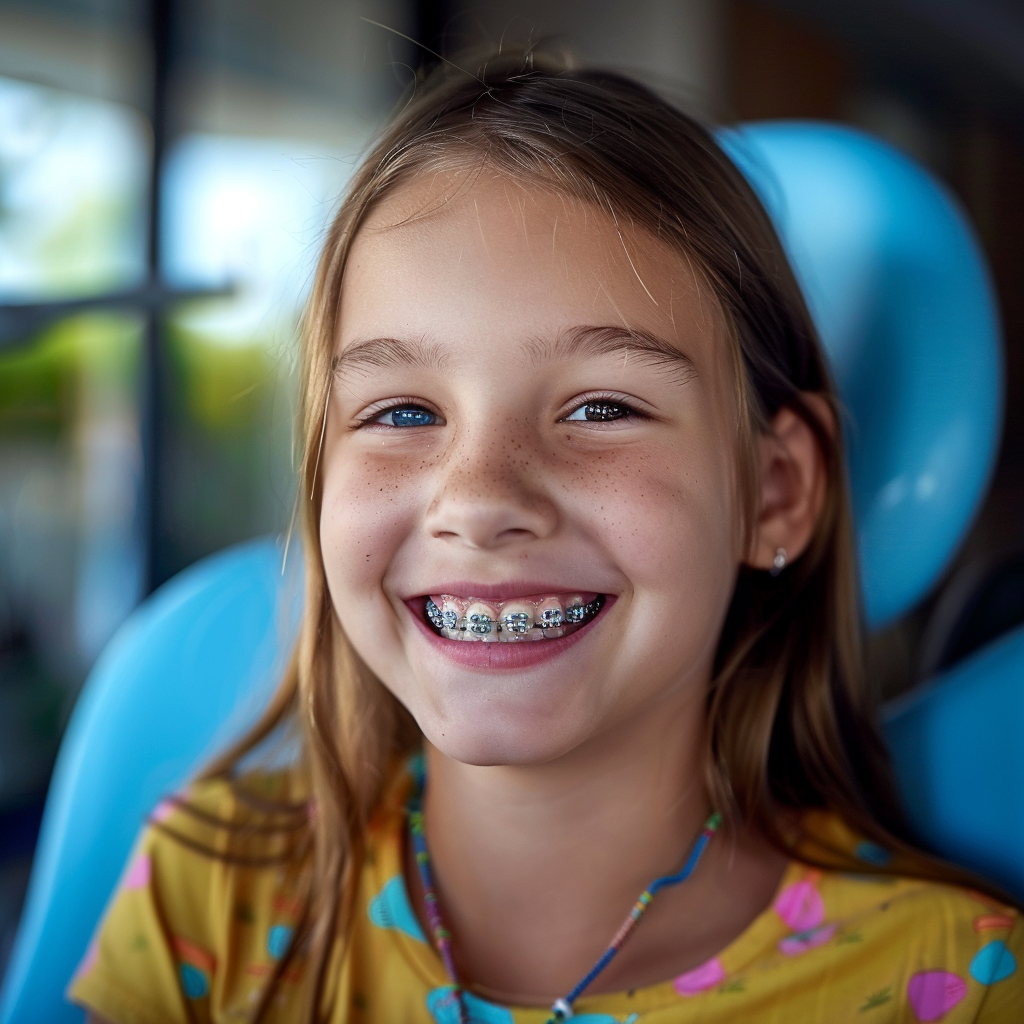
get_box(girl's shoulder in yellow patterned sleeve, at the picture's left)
[71,772,309,1022]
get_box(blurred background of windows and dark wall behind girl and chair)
[0,0,1024,974]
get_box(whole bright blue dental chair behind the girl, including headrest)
[0,123,1007,1024]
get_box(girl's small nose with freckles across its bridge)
[425,423,558,550]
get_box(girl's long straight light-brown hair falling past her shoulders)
[190,49,999,1021]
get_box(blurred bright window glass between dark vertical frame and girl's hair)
[158,134,359,577]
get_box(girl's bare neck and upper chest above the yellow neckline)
[407,684,781,1005]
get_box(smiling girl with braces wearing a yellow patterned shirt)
[72,46,1024,1024]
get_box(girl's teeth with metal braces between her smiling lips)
[424,594,605,643]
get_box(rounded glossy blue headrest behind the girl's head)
[722,121,1002,627]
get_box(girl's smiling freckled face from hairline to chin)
[321,174,740,764]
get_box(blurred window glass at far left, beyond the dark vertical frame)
[0,78,148,806]
